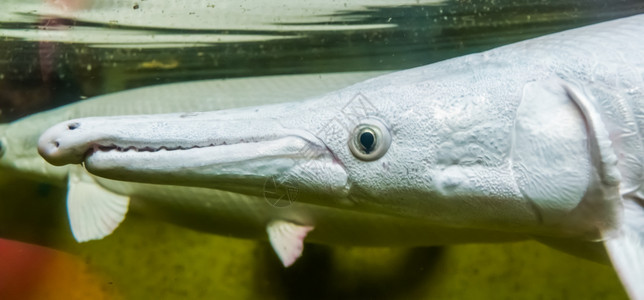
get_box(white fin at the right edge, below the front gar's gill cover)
[604,199,644,299]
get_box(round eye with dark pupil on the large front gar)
[349,119,391,161]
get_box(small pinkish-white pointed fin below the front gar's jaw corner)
[266,220,313,267]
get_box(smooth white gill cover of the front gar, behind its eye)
[512,78,621,241]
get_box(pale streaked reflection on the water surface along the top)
[0,0,443,48]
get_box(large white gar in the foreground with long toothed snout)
[39,15,644,299]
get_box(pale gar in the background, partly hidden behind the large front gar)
[6,72,525,246]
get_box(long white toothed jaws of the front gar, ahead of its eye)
[38,109,348,198]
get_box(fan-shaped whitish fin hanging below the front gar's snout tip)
[67,166,130,242]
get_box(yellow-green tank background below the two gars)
[0,175,627,299]
